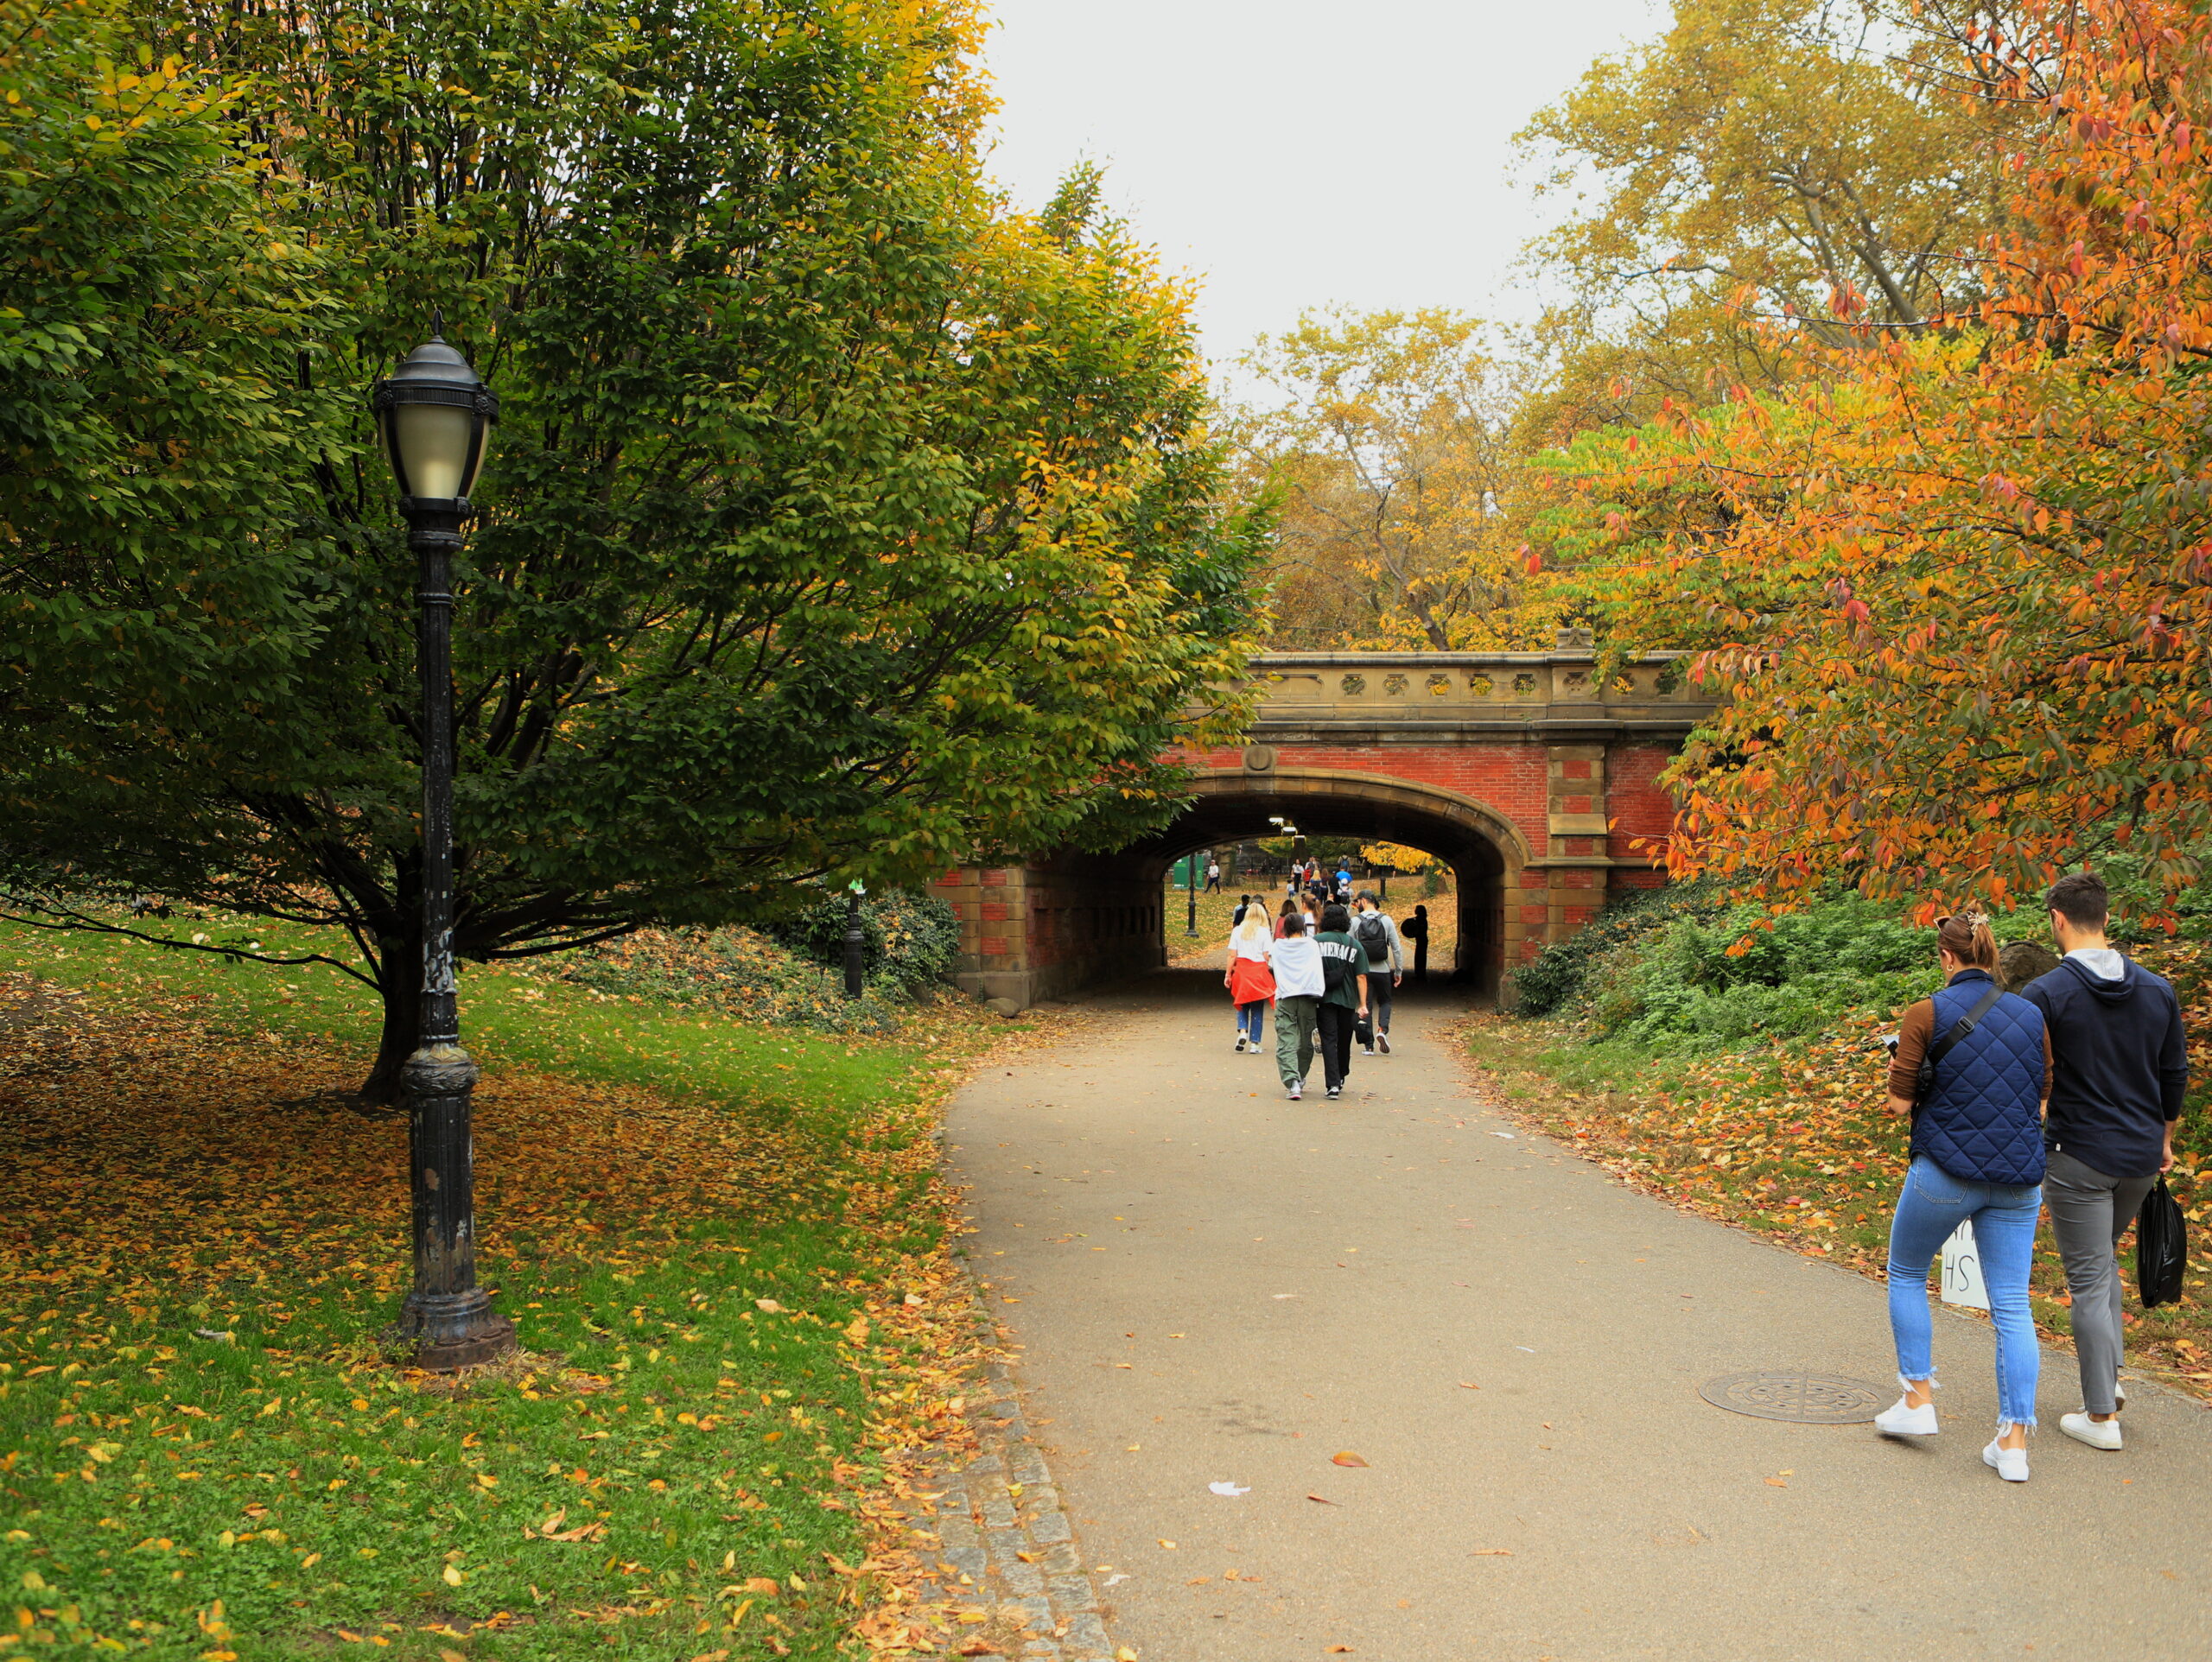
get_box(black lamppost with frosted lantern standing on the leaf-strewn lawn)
[370,318,515,1370]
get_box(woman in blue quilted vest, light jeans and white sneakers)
[1873,915,2050,1483]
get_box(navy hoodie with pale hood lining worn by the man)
[2019,957,2190,1178]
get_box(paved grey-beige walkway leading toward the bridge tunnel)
[949,973,2212,1662]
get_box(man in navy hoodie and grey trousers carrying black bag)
[2022,871,2190,1449]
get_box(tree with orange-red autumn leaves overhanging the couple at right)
[1553,0,2212,904]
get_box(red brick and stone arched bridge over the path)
[938,634,1712,1005]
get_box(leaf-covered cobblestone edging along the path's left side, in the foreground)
[913,1291,1115,1662]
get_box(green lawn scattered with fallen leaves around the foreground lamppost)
[0,922,982,1662]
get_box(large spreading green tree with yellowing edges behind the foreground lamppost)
[0,0,1259,1094]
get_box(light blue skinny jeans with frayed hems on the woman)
[1889,1156,2044,1425]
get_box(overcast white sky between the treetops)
[984,0,1668,389]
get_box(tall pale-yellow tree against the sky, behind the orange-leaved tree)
[1520,0,2029,438]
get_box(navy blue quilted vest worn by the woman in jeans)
[1913,970,2044,1184]
